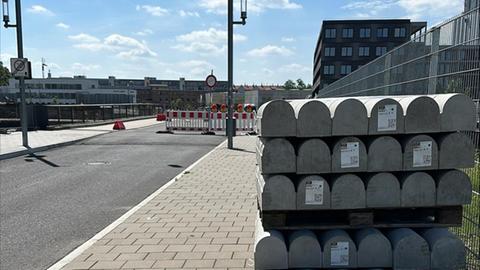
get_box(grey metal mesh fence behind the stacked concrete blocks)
[313,6,480,269]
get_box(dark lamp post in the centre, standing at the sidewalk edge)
[227,0,247,149]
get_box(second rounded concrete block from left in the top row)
[288,99,332,138]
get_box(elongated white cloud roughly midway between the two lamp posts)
[69,33,157,60]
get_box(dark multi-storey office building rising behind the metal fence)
[313,20,427,93]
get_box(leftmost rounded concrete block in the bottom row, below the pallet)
[254,218,288,270]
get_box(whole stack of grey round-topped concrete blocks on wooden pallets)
[255,94,476,269]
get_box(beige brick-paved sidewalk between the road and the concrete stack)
[55,136,257,270]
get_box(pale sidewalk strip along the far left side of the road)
[0,117,158,158]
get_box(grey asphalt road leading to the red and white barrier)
[0,126,224,270]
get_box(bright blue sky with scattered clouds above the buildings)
[0,0,463,84]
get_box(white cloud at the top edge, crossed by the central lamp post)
[199,0,302,14]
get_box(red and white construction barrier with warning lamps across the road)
[166,111,255,131]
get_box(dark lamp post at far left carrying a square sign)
[2,0,29,148]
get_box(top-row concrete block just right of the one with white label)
[395,96,440,133]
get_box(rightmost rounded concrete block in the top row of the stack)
[433,93,477,132]
